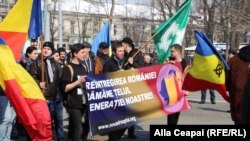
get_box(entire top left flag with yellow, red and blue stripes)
[0,0,42,61]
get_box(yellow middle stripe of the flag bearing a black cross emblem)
[189,54,225,84]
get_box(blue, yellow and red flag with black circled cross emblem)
[182,30,229,102]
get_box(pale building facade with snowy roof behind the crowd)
[0,0,163,52]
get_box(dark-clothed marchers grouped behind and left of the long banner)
[0,37,158,141]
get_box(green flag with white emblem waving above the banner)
[153,0,192,64]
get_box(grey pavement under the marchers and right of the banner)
[13,91,233,141]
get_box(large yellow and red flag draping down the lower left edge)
[0,37,52,141]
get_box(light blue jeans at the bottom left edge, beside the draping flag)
[0,96,16,141]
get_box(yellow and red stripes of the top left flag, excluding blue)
[0,0,33,60]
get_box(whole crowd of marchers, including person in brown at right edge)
[0,37,250,141]
